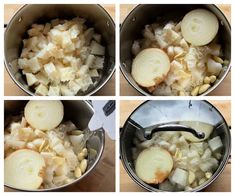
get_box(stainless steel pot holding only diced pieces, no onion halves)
[4,4,115,95]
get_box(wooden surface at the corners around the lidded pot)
[120,100,231,192]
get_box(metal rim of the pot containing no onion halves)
[4,4,116,96]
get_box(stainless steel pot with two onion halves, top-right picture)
[120,4,231,95]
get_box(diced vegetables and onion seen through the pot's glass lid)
[132,121,223,191]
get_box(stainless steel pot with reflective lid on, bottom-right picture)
[120,100,231,192]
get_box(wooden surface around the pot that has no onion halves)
[4,4,115,96]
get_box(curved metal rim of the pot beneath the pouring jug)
[4,100,105,192]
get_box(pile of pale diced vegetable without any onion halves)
[15,17,105,96]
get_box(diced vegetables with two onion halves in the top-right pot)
[131,9,229,96]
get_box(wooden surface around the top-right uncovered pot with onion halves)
[120,4,231,96]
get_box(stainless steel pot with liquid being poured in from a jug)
[4,100,105,191]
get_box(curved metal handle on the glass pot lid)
[144,124,205,139]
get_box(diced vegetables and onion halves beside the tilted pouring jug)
[4,101,96,190]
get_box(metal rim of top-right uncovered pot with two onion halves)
[119,4,232,97]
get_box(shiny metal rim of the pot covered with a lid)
[119,100,231,192]
